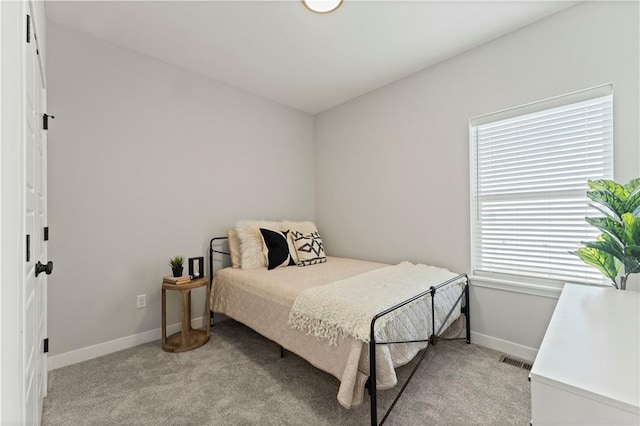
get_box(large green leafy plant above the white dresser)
[573,178,640,290]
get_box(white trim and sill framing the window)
[469,83,615,290]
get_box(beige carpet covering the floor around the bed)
[43,320,530,425]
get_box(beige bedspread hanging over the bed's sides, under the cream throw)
[211,257,463,408]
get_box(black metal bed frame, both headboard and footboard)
[209,237,471,426]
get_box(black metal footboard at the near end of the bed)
[367,274,471,426]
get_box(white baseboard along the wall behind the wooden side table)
[48,317,206,371]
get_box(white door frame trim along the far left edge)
[0,1,28,424]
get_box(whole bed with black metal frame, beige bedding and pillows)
[209,221,469,424]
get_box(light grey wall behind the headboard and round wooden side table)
[48,23,314,365]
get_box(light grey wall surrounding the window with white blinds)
[315,2,640,358]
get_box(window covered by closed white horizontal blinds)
[470,85,613,284]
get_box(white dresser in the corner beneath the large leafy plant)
[530,284,640,426]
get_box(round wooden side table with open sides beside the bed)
[162,277,211,352]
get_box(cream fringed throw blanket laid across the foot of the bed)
[289,262,464,344]
